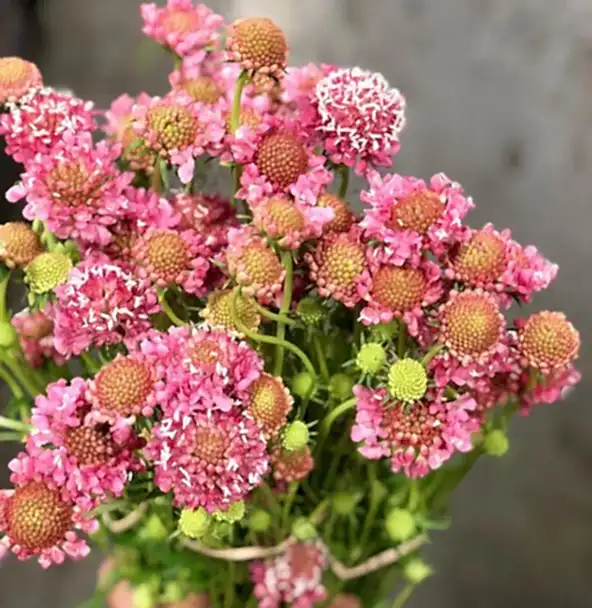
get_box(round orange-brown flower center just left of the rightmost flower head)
[441,291,503,356]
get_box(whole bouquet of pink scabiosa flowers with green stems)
[0,0,579,608]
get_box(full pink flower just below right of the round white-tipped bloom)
[360,172,474,264]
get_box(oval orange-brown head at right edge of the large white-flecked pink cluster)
[245,374,294,439]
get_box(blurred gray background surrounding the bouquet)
[0,0,592,608]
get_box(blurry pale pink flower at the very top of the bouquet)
[141,0,224,59]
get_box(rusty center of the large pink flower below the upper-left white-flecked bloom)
[45,160,108,207]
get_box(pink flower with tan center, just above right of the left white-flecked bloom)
[132,229,212,296]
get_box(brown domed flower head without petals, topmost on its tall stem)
[232,17,288,70]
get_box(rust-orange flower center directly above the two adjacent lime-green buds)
[372,266,427,313]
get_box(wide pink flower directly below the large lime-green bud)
[351,385,479,478]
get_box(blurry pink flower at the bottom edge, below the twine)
[251,542,328,608]
